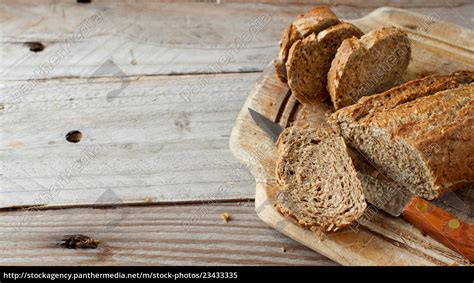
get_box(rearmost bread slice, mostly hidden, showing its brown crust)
[273,7,339,82]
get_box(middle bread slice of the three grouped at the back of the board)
[286,23,363,105]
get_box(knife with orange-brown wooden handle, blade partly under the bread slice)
[248,108,474,262]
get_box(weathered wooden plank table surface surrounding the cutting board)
[0,0,474,265]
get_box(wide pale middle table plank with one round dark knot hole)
[0,73,259,207]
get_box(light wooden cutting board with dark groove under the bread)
[230,8,474,265]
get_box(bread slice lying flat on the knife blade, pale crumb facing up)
[276,127,367,235]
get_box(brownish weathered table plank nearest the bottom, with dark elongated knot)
[0,201,335,265]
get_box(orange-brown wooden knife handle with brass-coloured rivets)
[402,196,474,262]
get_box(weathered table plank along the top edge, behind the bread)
[0,0,474,80]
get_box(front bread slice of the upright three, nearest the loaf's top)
[327,27,411,109]
